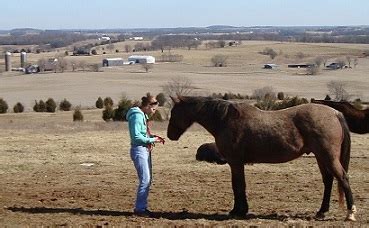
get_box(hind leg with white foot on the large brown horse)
[332,160,356,221]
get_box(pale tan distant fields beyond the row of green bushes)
[0,41,369,110]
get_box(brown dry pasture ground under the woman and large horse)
[0,111,369,227]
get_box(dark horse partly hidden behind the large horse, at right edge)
[311,99,369,134]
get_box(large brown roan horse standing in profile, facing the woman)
[167,97,356,220]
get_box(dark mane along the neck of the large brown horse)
[183,97,232,120]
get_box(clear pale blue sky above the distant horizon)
[0,0,369,30]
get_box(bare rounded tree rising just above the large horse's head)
[163,77,194,96]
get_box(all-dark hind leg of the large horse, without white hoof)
[316,158,333,219]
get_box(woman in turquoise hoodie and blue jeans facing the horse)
[126,95,164,216]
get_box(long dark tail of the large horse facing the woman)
[337,112,351,207]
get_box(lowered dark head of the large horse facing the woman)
[167,97,193,140]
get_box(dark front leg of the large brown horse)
[229,164,249,217]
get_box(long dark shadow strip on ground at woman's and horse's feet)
[7,207,320,221]
